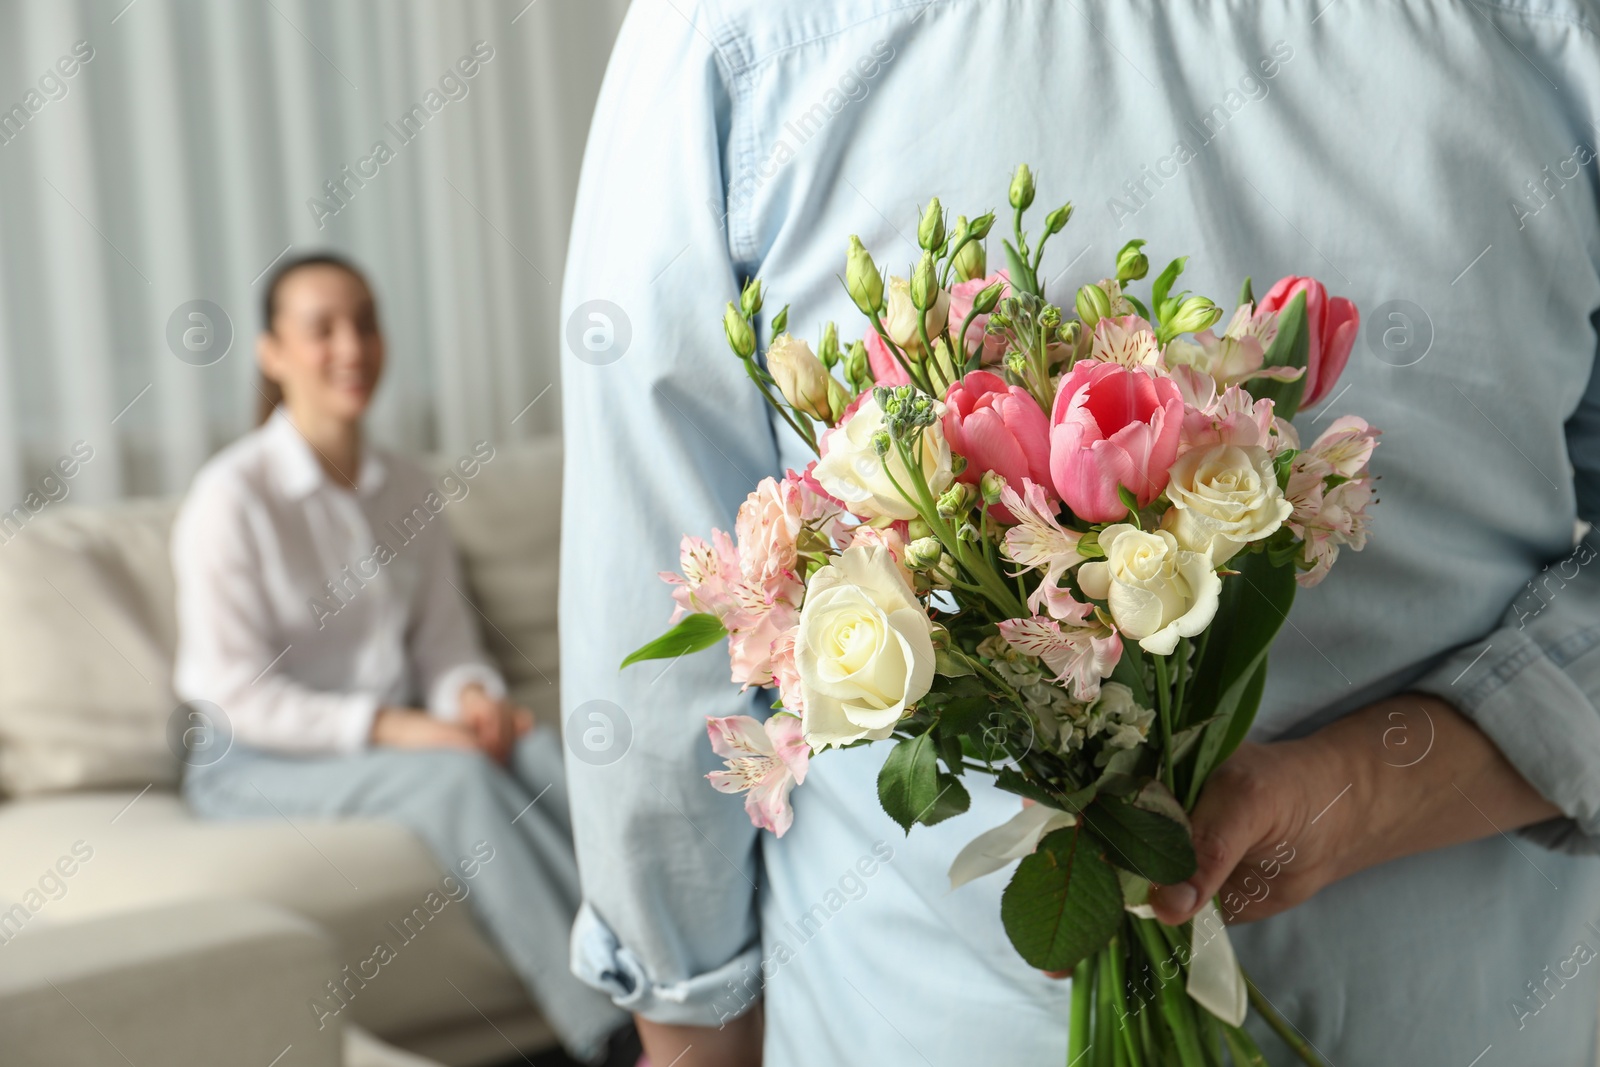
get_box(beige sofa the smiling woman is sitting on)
[0,443,560,1067]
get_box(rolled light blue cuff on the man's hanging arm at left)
[571,901,762,1027]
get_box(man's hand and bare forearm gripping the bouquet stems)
[1150,693,1560,925]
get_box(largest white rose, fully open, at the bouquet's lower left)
[795,545,933,749]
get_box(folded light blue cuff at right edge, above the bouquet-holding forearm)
[1411,627,1600,854]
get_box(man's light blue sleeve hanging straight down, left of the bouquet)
[560,0,778,1025]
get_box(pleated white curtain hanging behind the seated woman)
[0,0,626,512]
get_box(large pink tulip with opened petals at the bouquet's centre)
[1050,360,1184,523]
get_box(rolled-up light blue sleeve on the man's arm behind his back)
[1414,337,1600,853]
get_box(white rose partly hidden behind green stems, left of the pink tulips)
[813,395,955,518]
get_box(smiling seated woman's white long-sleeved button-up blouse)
[173,408,506,755]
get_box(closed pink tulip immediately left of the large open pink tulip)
[944,371,1050,522]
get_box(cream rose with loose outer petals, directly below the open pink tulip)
[1078,523,1222,656]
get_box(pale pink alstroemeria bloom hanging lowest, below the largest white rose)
[706,712,811,837]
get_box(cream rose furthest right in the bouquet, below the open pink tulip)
[1162,445,1294,565]
